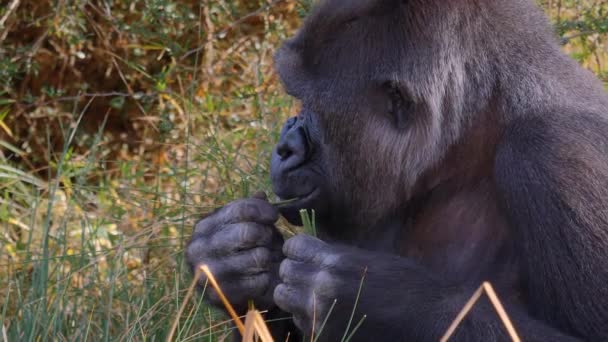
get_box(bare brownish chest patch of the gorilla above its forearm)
[399,181,516,281]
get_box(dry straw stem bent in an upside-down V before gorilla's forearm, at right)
[439,281,521,342]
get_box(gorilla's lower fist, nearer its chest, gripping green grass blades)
[274,235,366,340]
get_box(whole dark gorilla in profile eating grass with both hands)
[186,0,608,341]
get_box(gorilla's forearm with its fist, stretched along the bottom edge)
[274,235,575,341]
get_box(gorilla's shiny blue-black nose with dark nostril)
[276,118,308,170]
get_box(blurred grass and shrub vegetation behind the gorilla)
[0,0,608,341]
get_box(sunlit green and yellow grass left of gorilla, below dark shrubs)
[0,92,291,341]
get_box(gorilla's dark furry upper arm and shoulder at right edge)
[495,114,608,340]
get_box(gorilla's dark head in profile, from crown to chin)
[271,0,556,232]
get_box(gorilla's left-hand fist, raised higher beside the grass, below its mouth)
[186,193,283,313]
